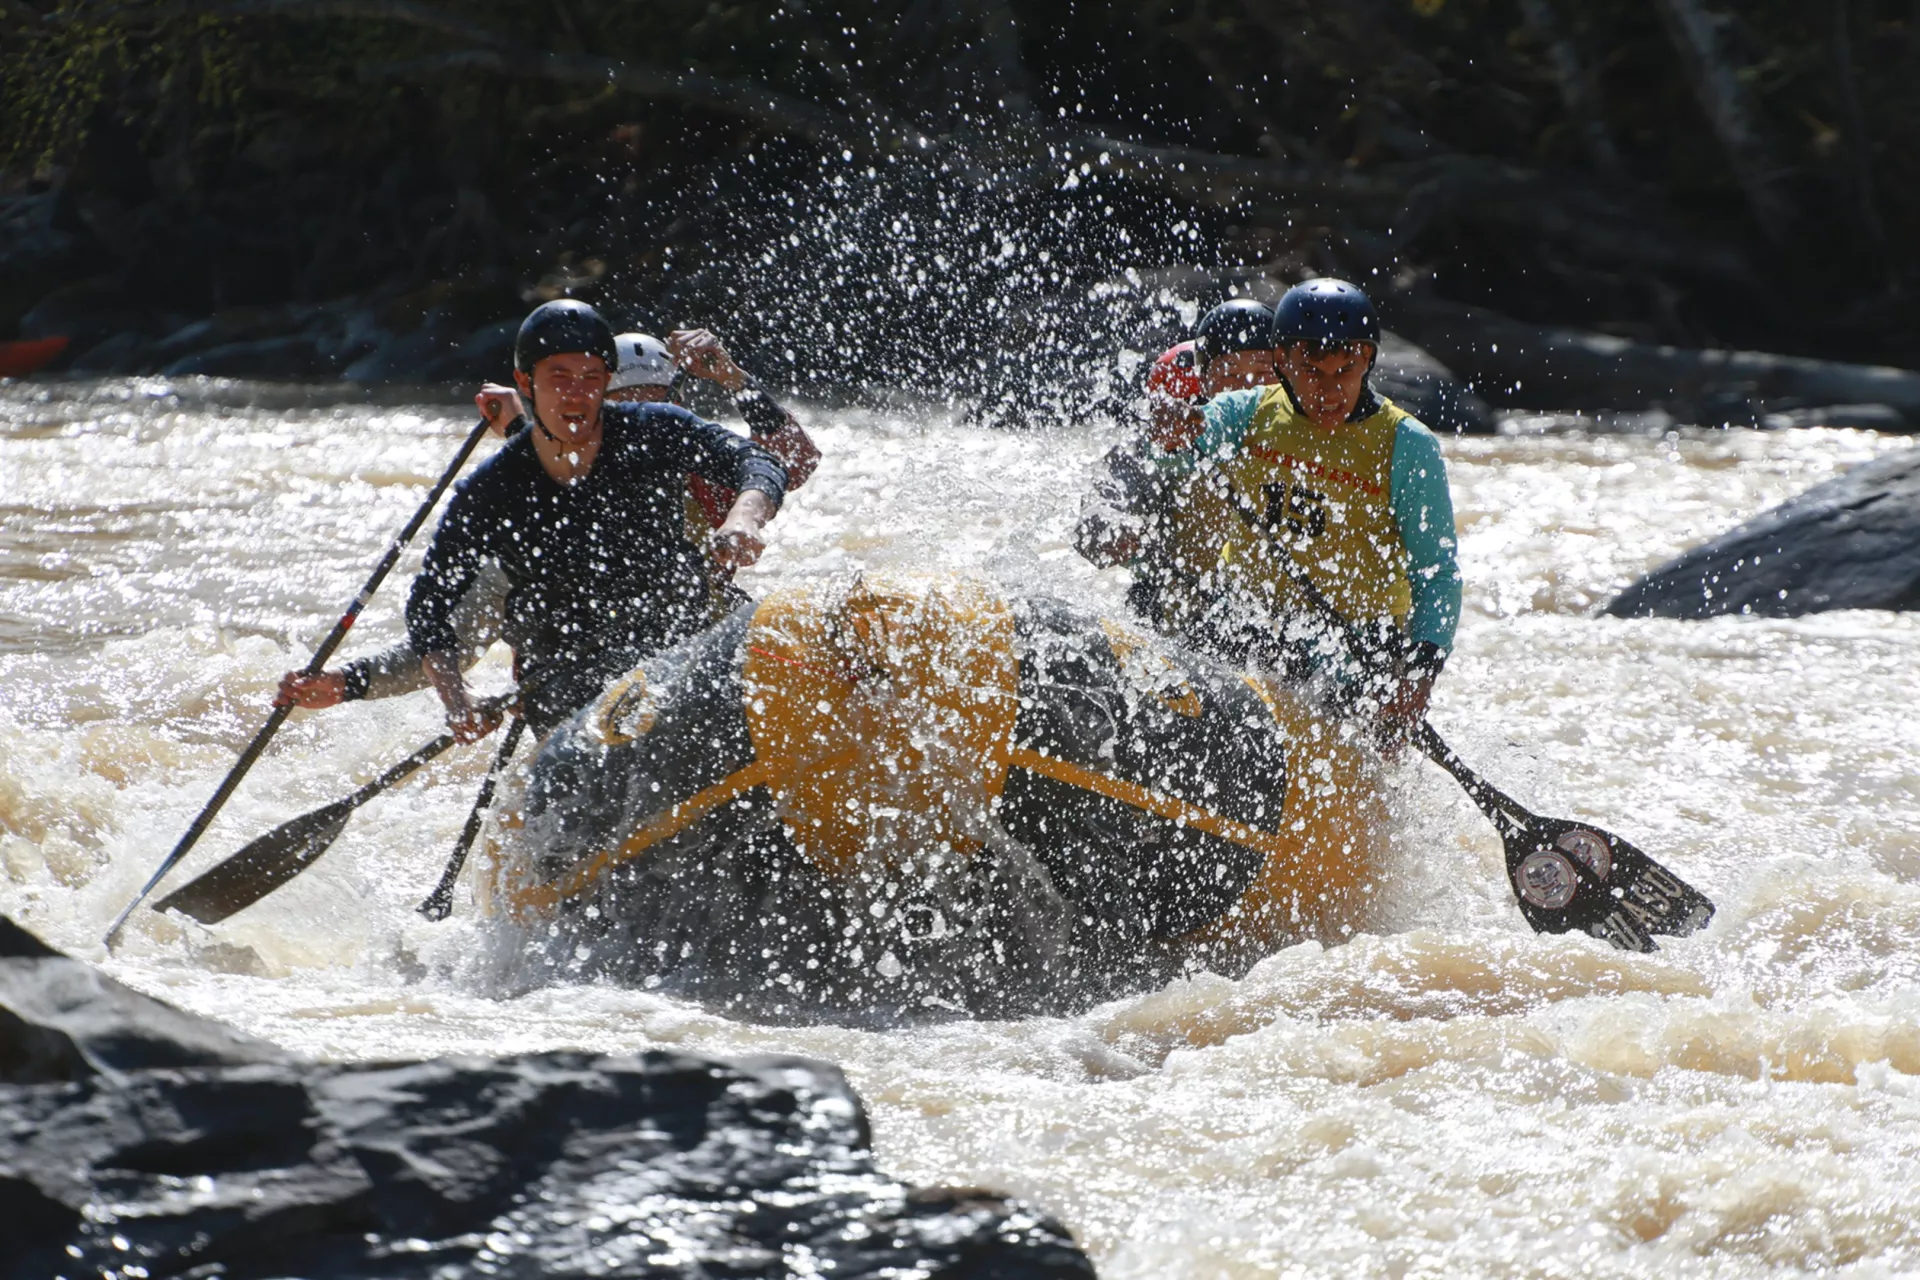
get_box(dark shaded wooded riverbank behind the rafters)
[0,0,1920,410]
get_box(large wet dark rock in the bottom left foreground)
[0,919,1094,1280]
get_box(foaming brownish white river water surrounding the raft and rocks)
[0,380,1920,1280]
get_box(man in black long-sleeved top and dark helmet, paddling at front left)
[407,301,787,743]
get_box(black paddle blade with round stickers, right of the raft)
[1501,818,1713,952]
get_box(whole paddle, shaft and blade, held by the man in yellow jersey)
[1213,514,1713,952]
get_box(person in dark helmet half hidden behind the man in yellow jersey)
[1073,297,1273,633]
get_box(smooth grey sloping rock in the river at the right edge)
[1603,449,1920,618]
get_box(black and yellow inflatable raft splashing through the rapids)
[476,576,1382,1021]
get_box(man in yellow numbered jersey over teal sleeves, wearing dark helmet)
[1188,280,1461,737]
